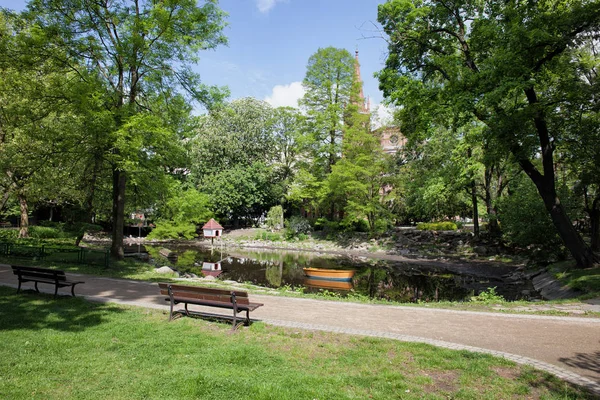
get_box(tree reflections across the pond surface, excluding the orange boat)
[147,246,510,302]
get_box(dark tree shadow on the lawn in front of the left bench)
[0,287,123,332]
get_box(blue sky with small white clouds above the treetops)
[0,0,386,118]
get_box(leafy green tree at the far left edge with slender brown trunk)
[0,13,98,237]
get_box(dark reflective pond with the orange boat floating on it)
[146,246,534,302]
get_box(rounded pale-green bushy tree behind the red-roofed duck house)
[191,98,285,224]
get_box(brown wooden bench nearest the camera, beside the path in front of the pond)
[158,283,263,330]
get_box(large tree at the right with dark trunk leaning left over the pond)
[378,0,600,267]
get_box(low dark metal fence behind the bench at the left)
[0,243,110,267]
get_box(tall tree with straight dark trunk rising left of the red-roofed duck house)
[29,0,225,258]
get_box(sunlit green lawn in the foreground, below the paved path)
[0,287,593,400]
